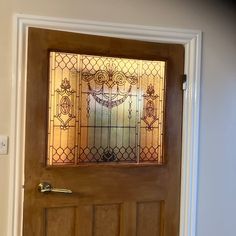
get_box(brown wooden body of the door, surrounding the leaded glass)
[23,28,184,236]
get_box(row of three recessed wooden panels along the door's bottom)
[44,201,164,236]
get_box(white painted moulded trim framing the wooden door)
[7,14,202,236]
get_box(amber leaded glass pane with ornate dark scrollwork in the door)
[47,52,165,165]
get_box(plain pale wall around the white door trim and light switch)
[0,0,236,236]
